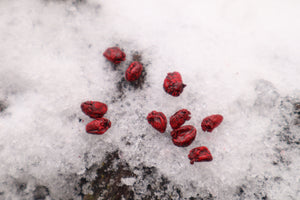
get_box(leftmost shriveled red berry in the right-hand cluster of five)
[147,111,167,133]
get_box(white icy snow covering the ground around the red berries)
[0,0,300,200]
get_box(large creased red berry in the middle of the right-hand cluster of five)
[171,125,197,147]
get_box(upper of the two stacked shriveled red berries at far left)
[81,101,107,119]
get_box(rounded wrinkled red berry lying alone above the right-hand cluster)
[164,72,186,97]
